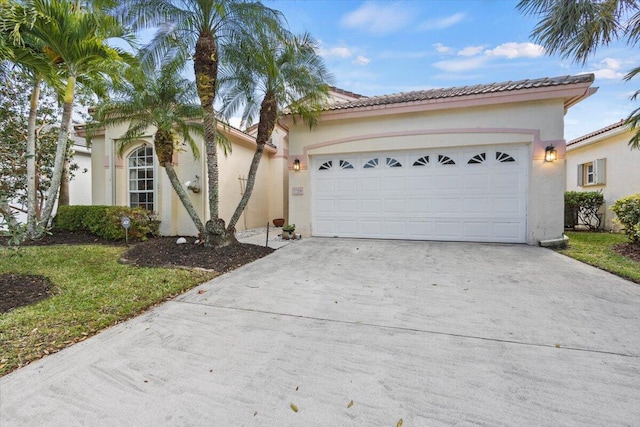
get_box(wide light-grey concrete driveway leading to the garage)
[0,239,640,427]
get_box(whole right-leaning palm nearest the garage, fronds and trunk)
[221,31,330,233]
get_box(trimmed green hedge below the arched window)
[55,206,159,240]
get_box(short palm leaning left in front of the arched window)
[91,56,204,234]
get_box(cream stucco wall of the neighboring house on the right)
[566,130,640,230]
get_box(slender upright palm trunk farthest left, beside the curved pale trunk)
[26,77,42,238]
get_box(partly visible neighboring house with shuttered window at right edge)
[567,120,640,230]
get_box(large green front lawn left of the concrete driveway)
[0,245,215,376]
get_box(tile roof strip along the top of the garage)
[325,74,594,111]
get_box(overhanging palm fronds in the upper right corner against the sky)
[517,0,640,149]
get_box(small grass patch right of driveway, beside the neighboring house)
[559,232,640,283]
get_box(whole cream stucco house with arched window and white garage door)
[79,74,596,244]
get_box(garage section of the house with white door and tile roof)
[285,74,596,244]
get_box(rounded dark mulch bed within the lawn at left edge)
[0,273,52,313]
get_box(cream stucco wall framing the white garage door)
[288,99,565,244]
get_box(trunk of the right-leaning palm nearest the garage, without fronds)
[227,92,278,232]
